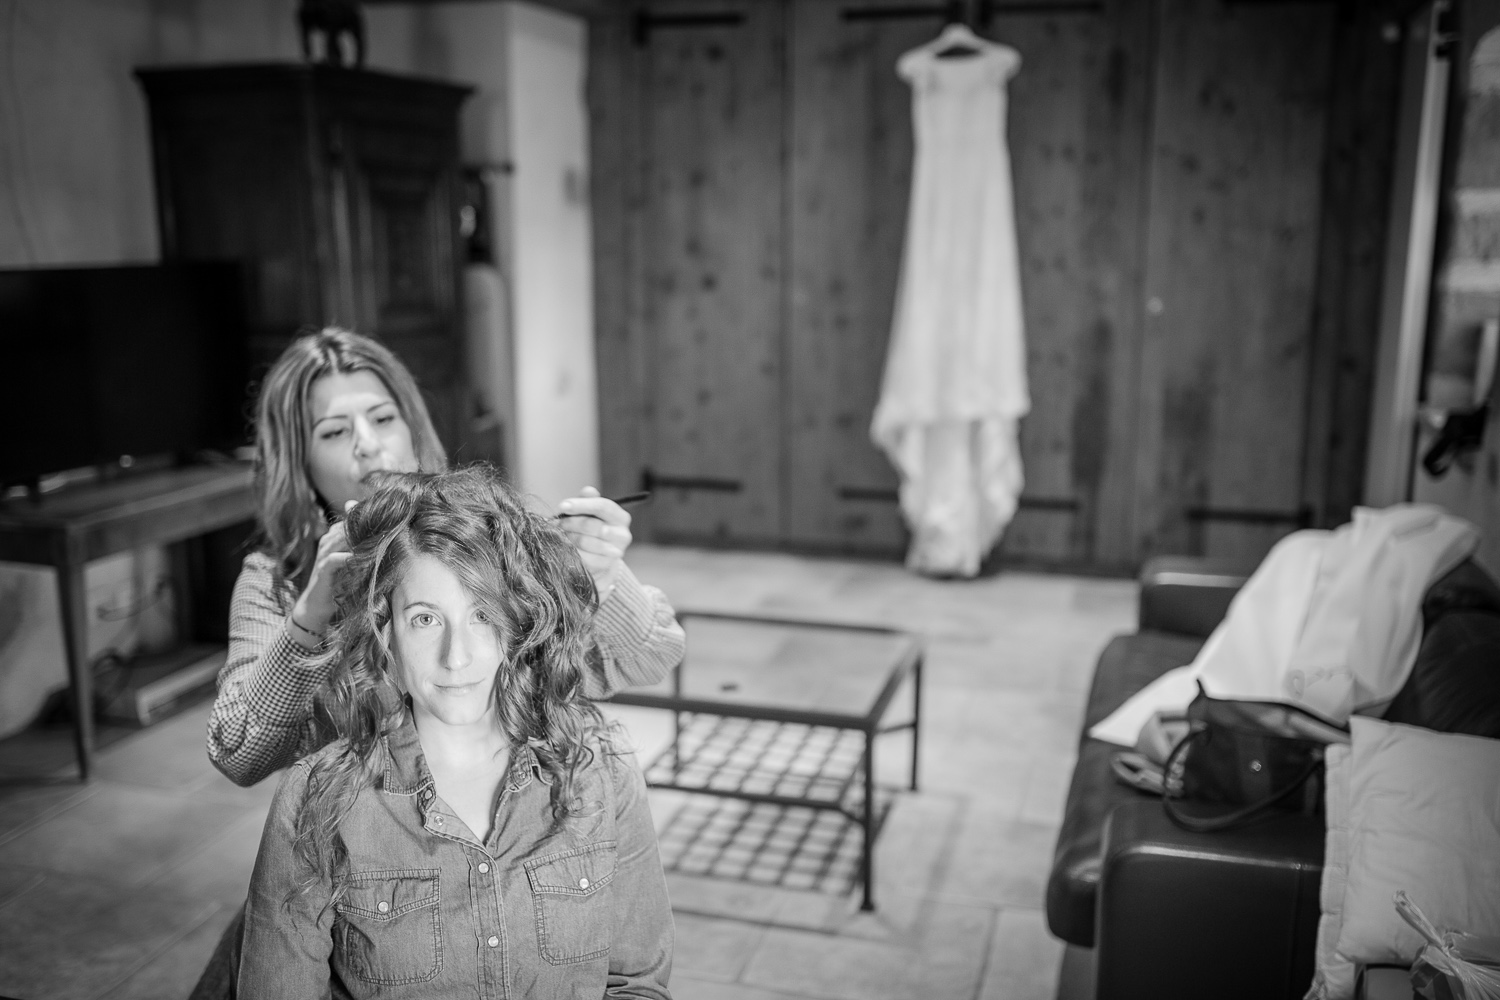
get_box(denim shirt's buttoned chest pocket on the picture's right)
[525,841,617,966]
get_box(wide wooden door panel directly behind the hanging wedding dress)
[786,0,1148,562]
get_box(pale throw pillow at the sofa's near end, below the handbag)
[1308,717,1500,1000]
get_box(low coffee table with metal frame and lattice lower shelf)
[611,612,923,910]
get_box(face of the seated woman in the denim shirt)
[390,556,504,726]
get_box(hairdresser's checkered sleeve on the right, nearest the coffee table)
[584,567,687,699]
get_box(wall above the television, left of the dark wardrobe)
[0,0,300,267]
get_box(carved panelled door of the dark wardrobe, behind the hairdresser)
[330,112,467,454]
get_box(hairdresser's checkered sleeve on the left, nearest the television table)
[209,553,327,786]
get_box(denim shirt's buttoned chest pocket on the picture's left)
[333,868,443,985]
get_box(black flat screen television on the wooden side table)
[0,262,249,484]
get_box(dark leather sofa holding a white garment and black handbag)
[1047,558,1500,1000]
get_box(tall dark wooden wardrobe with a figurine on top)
[137,64,468,451]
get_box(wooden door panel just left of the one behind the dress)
[632,0,785,543]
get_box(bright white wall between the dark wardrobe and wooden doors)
[365,3,599,504]
